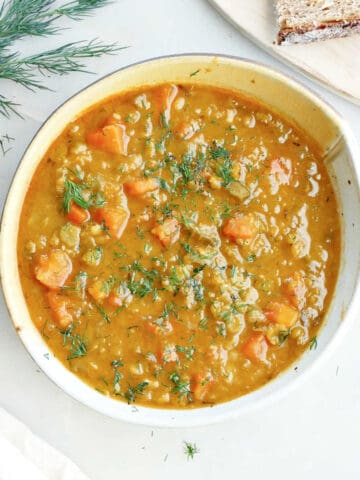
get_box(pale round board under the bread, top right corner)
[209,0,360,105]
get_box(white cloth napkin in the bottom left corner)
[0,408,89,480]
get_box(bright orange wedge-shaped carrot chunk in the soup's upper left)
[86,123,129,155]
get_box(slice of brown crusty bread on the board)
[275,0,360,45]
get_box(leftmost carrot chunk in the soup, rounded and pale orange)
[35,250,72,289]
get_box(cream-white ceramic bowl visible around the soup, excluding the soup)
[0,55,360,426]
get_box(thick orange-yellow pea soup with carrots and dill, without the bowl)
[18,84,341,408]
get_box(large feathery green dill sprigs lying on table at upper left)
[0,0,121,117]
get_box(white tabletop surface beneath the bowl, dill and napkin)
[0,0,360,480]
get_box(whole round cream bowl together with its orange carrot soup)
[0,55,360,426]
